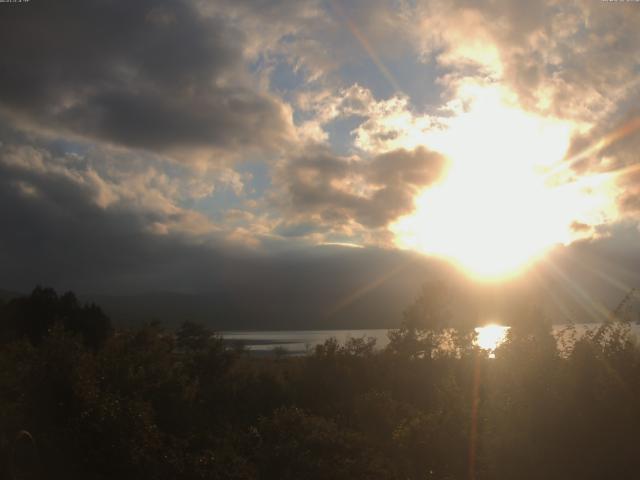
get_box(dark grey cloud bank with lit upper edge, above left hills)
[0,135,232,291]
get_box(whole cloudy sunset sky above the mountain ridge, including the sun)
[0,0,640,322]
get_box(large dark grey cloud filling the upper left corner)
[0,0,290,151]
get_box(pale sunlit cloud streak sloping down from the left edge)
[0,140,220,237]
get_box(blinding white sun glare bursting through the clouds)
[391,87,611,280]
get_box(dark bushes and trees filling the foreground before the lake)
[0,289,640,480]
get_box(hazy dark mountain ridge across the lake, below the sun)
[0,244,635,330]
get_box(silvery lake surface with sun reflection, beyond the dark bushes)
[221,323,640,355]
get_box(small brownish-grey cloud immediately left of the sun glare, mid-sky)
[279,147,445,228]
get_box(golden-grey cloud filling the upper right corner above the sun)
[416,0,640,123]
